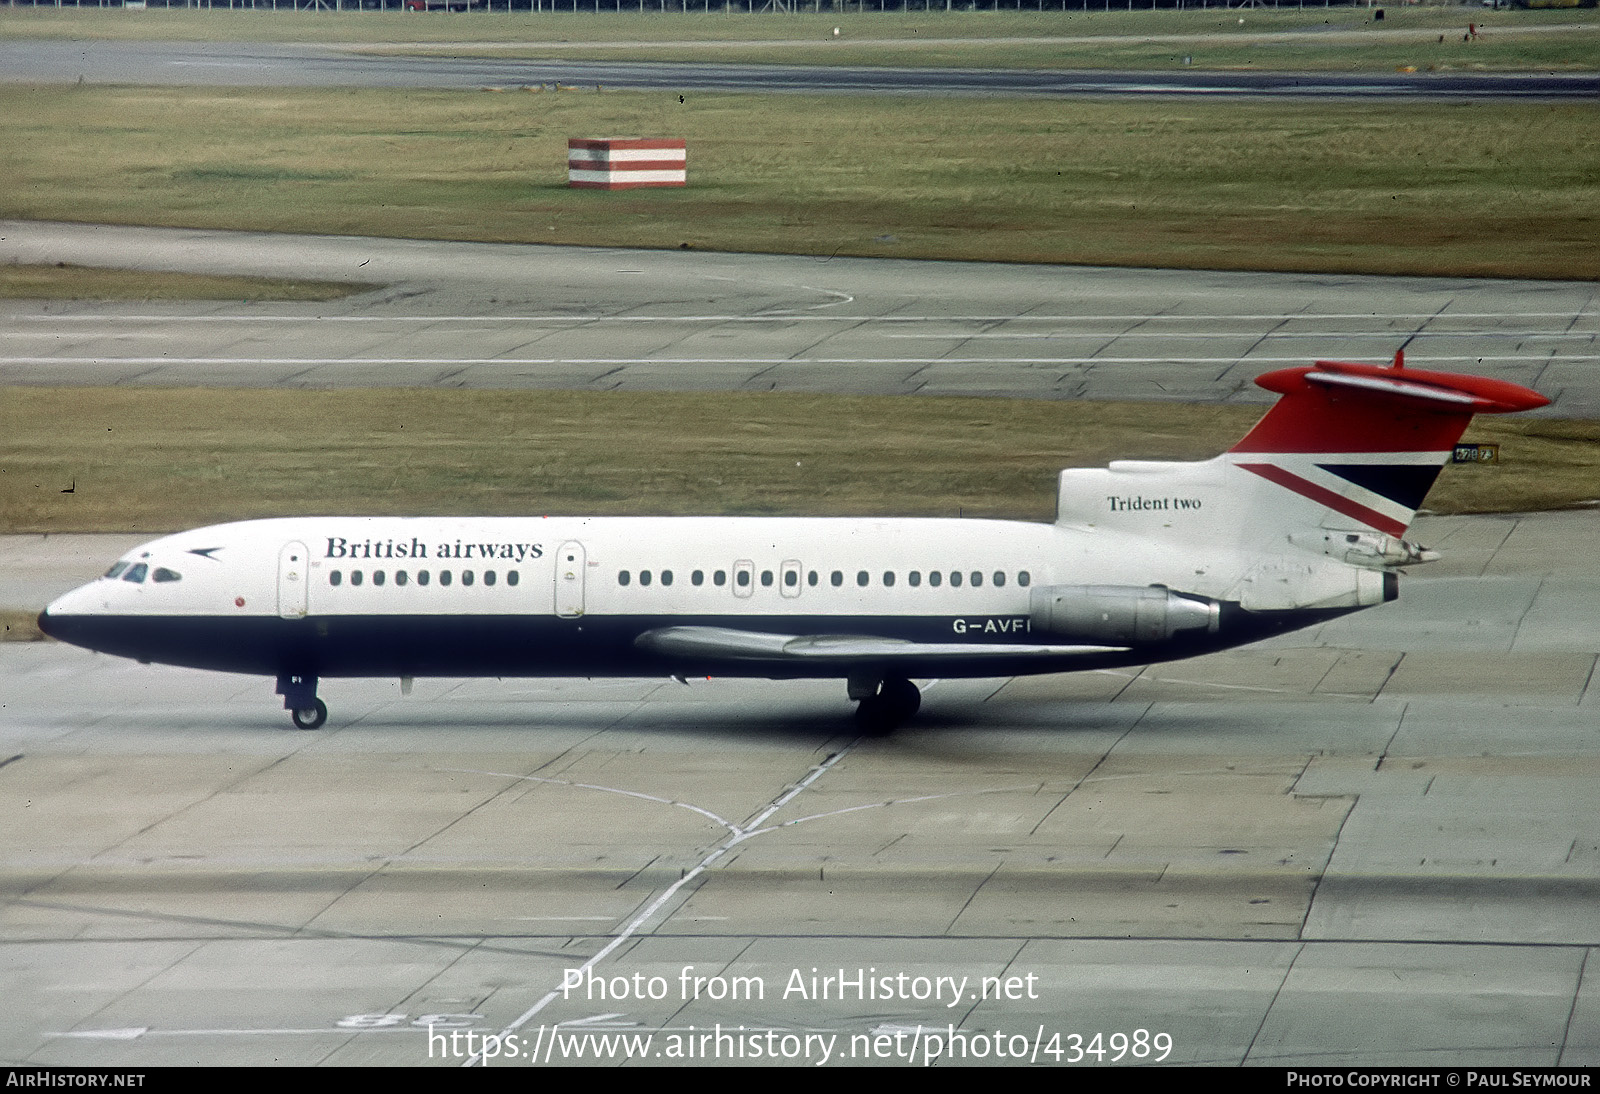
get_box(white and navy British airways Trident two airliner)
[38,353,1549,733]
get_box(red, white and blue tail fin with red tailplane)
[1226,350,1550,537]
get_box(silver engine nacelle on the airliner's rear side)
[1030,585,1221,646]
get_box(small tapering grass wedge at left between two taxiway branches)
[0,262,371,301]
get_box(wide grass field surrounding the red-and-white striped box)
[0,86,1600,278]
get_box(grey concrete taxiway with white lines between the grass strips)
[0,221,1600,417]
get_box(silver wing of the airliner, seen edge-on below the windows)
[634,627,1128,667]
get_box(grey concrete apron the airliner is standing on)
[0,512,1600,1067]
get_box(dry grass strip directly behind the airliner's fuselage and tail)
[0,387,1600,533]
